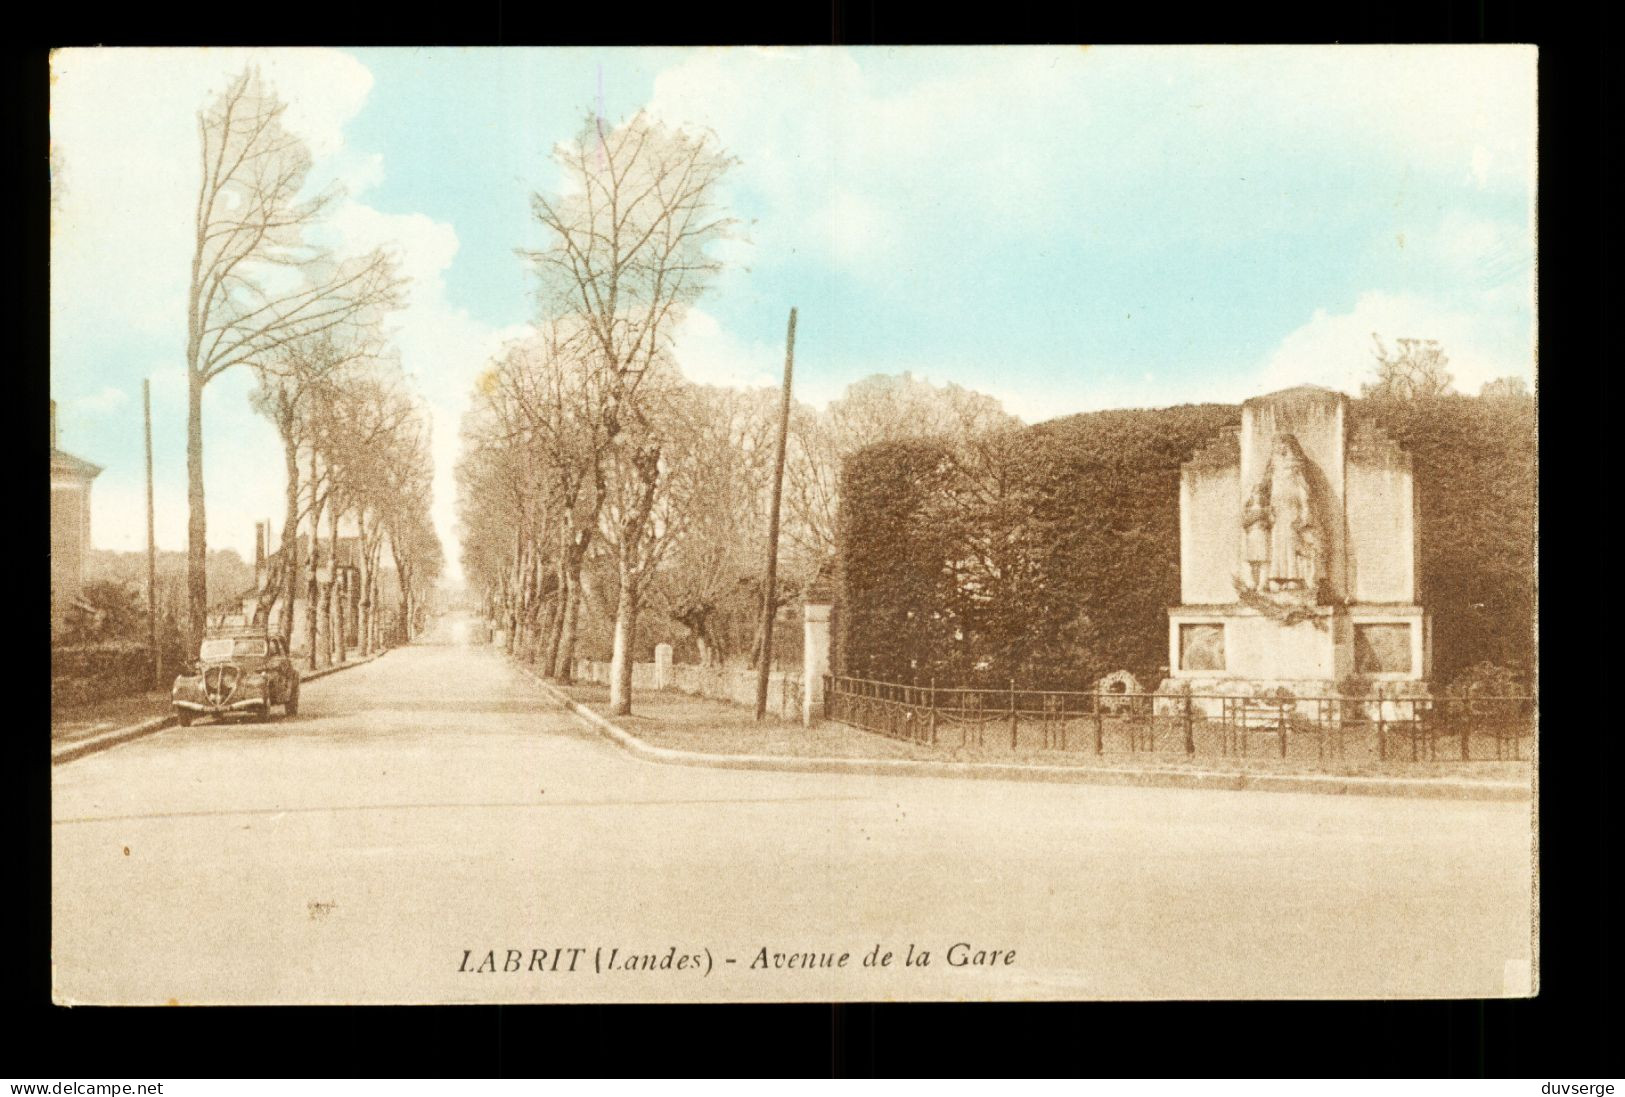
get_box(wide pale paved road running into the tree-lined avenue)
[52,617,1531,1003]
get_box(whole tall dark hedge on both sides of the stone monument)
[835,397,1534,687]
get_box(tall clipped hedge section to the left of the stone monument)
[837,405,1240,687]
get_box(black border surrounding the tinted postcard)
[9,0,1625,1081]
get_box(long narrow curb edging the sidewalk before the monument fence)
[514,663,1532,801]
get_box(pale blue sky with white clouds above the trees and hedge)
[50,47,1536,585]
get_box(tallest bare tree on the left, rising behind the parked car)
[187,68,403,642]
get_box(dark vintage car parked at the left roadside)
[169,627,299,726]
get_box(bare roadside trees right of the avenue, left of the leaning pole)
[458,115,747,712]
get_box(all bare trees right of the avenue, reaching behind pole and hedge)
[457,114,1012,712]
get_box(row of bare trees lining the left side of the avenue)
[187,68,440,666]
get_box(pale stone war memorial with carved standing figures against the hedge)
[1164,387,1430,708]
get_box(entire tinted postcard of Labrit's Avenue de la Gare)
[47,46,1541,1006]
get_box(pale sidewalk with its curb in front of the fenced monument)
[538,678,1532,800]
